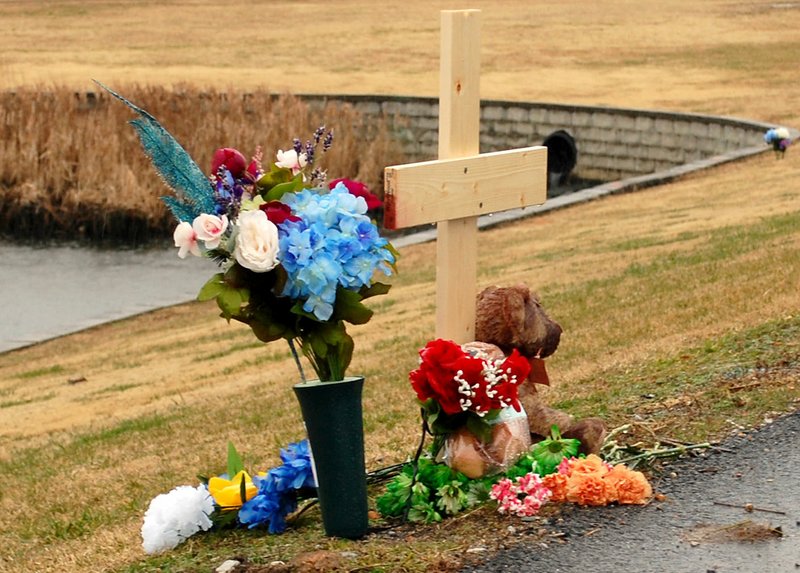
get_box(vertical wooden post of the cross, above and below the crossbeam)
[436,10,481,343]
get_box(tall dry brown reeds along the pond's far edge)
[0,85,402,245]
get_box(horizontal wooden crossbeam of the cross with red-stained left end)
[383,146,547,229]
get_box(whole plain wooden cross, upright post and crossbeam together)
[384,10,547,344]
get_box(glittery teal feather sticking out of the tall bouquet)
[95,80,216,223]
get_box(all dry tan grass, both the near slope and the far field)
[0,0,800,571]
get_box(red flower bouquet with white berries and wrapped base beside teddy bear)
[409,339,530,478]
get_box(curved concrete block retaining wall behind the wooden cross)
[302,95,773,181]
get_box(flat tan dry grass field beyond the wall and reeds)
[0,0,800,125]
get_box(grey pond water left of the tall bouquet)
[0,244,216,352]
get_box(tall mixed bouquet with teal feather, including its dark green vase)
[100,84,397,537]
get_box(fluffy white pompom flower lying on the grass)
[142,485,214,554]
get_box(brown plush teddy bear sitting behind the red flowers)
[467,285,606,454]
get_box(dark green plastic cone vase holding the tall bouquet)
[294,377,369,539]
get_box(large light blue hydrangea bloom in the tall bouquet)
[280,183,394,321]
